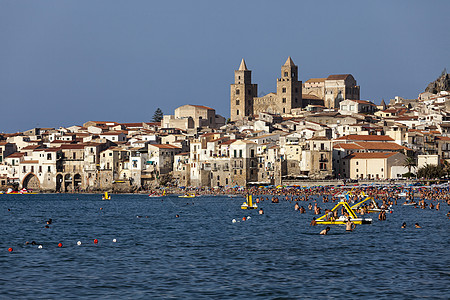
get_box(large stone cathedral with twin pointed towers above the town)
[230,57,359,121]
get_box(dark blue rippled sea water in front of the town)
[0,194,450,299]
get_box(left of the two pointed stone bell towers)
[230,59,258,121]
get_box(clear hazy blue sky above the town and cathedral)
[0,0,450,132]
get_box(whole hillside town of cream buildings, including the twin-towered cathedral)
[0,65,450,192]
